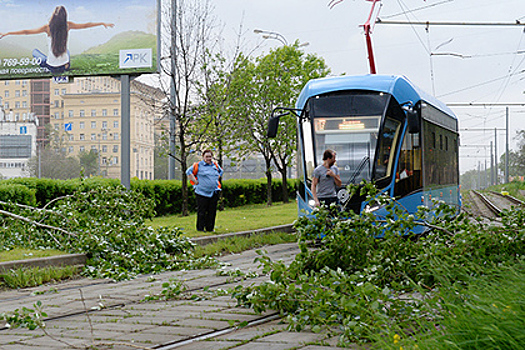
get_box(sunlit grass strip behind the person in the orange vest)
[149,201,297,237]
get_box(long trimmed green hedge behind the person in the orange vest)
[0,177,299,216]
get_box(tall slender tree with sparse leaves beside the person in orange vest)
[163,0,218,215]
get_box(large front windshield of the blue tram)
[303,92,390,186]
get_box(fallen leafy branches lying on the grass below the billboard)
[0,183,217,280]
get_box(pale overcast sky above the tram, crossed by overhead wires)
[213,0,525,173]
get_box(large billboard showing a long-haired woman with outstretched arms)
[0,0,160,79]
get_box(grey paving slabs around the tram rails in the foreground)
[0,244,346,350]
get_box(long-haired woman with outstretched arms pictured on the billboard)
[0,6,114,74]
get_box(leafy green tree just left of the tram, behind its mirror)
[229,42,330,205]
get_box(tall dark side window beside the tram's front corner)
[394,133,422,197]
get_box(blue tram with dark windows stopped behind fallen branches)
[269,75,460,230]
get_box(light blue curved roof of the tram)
[296,74,457,119]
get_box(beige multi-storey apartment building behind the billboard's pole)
[0,77,163,179]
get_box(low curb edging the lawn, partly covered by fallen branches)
[0,224,294,273]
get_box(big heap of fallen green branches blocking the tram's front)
[233,185,525,349]
